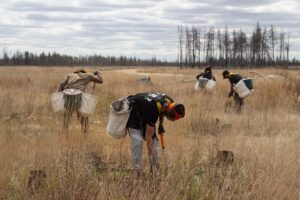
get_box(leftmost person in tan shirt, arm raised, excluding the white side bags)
[58,69,103,133]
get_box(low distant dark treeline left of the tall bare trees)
[0,51,170,66]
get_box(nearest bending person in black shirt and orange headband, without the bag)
[127,92,185,171]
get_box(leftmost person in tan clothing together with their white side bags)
[51,69,103,134]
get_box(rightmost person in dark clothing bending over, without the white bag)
[222,70,244,112]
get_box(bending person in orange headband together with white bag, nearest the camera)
[107,92,185,173]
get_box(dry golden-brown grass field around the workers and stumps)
[0,67,300,200]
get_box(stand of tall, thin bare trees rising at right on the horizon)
[178,22,300,67]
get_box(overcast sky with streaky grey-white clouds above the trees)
[0,0,300,60]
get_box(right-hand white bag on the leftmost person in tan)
[79,92,97,115]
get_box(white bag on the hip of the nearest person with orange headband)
[106,97,131,139]
